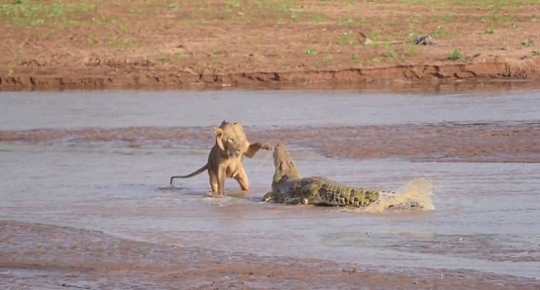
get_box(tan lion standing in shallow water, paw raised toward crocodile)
[170,120,272,195]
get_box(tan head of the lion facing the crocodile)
[215,121,249,158]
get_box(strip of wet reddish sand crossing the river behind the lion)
[0,122,540,163]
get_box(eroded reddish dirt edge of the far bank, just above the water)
[0,59,540,89]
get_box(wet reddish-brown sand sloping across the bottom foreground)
[0,221,540,289]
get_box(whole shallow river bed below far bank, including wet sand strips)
[0,83,540,289]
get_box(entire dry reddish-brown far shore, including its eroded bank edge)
[0,0,540,89]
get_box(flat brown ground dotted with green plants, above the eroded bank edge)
[0,0,540,81]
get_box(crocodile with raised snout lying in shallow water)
[262,142,419,208]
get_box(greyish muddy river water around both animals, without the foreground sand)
[0,91,540,284]
